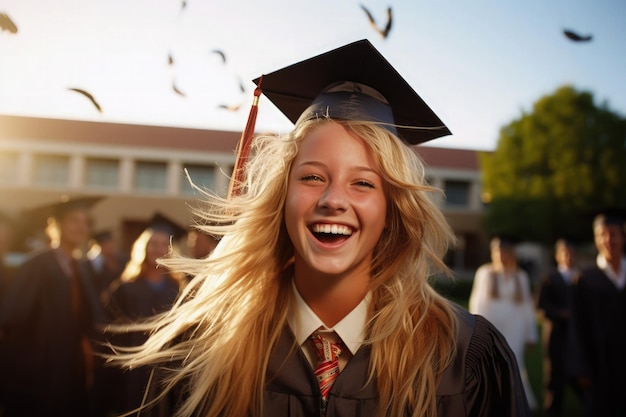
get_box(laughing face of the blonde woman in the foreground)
[285,123,387,285]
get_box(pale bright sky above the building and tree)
[0,0,626,150]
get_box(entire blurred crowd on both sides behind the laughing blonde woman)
[0,201,626,417]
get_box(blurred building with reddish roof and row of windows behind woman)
[0,116,485,269]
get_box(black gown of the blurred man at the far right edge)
[576,267,626,417]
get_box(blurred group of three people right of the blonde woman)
[469,210,626,417]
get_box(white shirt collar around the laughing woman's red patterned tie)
[288,281,371,355]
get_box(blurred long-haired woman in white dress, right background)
[469,238,538,410]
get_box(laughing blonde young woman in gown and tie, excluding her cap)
[116,39,528,417]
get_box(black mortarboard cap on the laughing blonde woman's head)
[254,40,450,145]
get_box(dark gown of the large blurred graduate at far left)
[0,250,104,416]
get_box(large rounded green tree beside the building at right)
[480,86,626,244]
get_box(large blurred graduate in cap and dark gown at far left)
[0,200,104,417]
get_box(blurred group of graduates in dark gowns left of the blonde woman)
[0,201,217,417]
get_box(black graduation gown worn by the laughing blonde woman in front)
[264,309,530,417]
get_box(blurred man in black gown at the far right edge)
[576,210,626,417]
